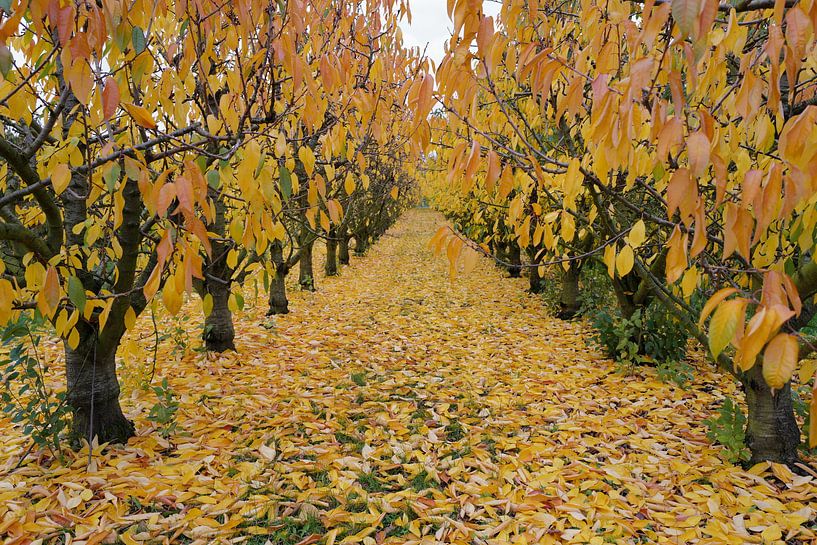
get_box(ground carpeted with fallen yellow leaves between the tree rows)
[0,211,817,545]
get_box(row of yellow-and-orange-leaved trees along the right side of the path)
[424,0,817,464]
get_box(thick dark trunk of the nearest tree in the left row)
[64,325,135,445]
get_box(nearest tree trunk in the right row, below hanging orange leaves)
[741,361,800,466]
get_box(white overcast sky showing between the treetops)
[400,0,502,68]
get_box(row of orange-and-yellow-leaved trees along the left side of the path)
[0,0,429,442]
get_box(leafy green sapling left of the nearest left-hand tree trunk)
[0,314,70,461]
